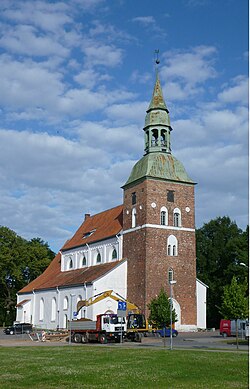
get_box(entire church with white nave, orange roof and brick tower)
[16,70,207,331]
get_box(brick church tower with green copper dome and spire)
[123,71,197,330]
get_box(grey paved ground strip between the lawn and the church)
[0,329,249,351]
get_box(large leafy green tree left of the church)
[0,226,55,324]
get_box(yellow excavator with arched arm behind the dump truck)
[72,290,148,342]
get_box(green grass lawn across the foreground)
[0,346,248,389]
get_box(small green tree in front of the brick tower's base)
[148,288,177,328]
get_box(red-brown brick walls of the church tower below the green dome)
[123,179,196,325]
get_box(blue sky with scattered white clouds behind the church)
[0,0,248,251]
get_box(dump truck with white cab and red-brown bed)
[69,313,126,344]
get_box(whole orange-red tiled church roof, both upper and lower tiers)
[19,205,123,293]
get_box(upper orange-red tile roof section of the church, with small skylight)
[62,205,123,251]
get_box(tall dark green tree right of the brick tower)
[196,216,248,328]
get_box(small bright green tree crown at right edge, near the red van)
[220,277,249,319]
